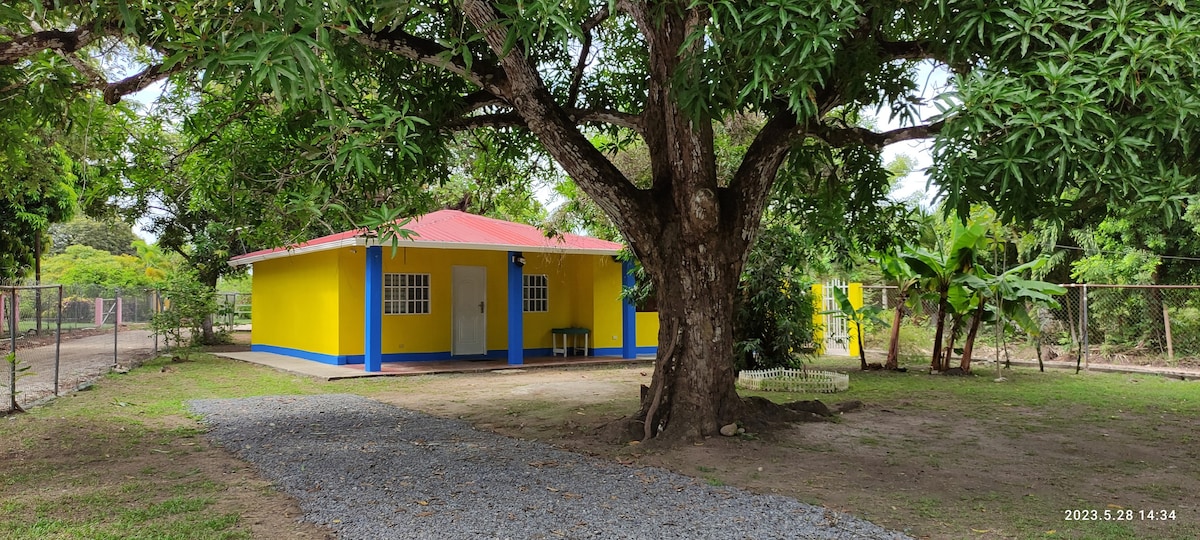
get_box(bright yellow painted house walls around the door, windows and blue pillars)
[252,247,658,355]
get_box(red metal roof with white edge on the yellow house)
[229,210,622,265]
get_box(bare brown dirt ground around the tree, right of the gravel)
[376,365,1200,539]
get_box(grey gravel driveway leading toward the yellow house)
[190,395,908,540]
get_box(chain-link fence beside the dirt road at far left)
[0,286,158,413]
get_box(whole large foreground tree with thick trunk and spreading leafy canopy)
[0,0,1200,438]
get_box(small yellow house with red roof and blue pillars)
[229,210,658,371]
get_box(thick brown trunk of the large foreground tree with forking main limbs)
[462,0,792,439]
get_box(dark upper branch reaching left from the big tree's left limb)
[354,30,505,95]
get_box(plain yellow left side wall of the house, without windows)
[251,251,345,355]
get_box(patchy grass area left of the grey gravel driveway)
[0,355,348,540]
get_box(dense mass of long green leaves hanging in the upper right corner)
[932,0,1200,218]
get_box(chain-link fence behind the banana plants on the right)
[863,284,1200,367]
